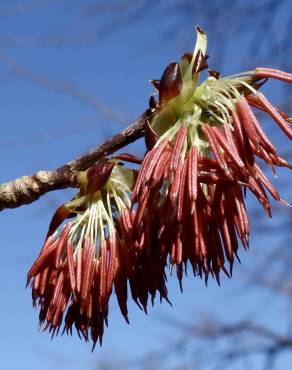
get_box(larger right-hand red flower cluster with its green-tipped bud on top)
[132,28,292,284]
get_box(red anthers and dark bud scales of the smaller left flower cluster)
[27,162,121,344]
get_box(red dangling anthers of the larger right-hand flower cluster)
[132,92,292,284]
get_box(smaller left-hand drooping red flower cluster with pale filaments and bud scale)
[28,162,144,344]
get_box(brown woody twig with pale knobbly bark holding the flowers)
[0,111,147,211]
